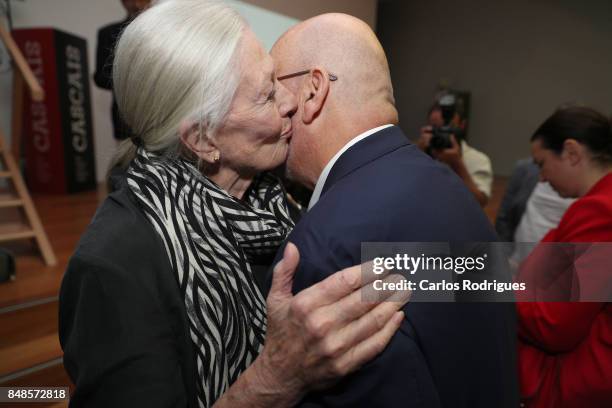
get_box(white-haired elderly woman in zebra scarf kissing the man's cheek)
[59,0,405,407]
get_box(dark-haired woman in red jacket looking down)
[517,108,612,408]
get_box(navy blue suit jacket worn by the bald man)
[266,126,518,408]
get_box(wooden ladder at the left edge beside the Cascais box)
[0,26,57,266]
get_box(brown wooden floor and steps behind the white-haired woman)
[0,177,506,408]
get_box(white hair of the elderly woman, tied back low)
[111,0,247,167]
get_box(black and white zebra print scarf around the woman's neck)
[127,148,293,407]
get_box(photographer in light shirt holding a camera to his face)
[416,94,493,207]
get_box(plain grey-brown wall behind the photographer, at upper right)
[378,0,612,174]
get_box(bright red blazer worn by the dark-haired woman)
[517,173,612,408]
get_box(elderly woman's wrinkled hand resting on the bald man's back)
[246,243,410,406]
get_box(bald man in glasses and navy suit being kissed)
[271,14,518,408]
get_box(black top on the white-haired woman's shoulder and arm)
[59,178,198,408]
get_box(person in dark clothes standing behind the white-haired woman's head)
[94,0,151,140]
